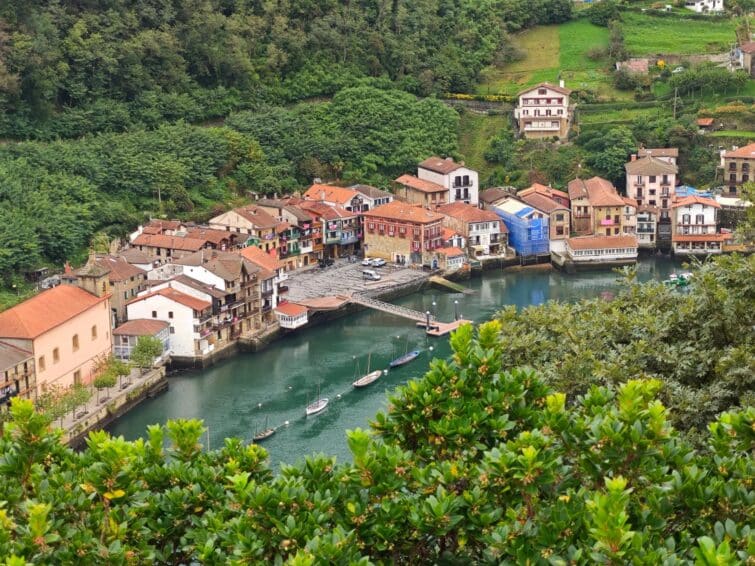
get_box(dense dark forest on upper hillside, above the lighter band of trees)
[0,0,571,138]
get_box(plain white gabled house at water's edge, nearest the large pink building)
[126,288,214,357]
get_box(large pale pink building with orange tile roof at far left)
[0,282,112,393]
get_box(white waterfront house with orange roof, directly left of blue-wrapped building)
[436,201,507,257]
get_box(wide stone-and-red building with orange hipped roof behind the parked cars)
[364,201,444,265]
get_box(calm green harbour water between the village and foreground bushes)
[111,258,679,467]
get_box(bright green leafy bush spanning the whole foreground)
[0,322,755,564]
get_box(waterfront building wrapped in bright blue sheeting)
[493,198,550,256]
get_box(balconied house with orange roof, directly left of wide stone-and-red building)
[298,200,362,259]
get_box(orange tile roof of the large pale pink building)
[0,285,109,340]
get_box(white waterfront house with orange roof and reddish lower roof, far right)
[671,196,731,255]
